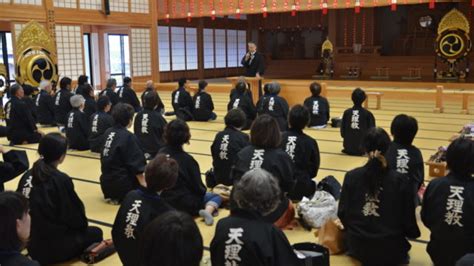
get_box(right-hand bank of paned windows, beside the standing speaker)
[203,29,247,69]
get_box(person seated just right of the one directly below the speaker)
[261,82,289,132]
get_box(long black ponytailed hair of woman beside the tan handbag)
[364,127,390,196]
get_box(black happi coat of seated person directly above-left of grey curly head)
[211,127,249,186]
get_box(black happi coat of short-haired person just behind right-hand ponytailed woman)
[385,142,425,191]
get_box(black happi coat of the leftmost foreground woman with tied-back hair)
[17,170,88,264]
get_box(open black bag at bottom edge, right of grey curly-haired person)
[293,242,330,266]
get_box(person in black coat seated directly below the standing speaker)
[227,82,257,130]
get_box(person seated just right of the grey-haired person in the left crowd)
[89,96,114,153]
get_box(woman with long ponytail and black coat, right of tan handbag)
[338,128,420,265]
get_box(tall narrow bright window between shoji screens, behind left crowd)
[109,34,130,86]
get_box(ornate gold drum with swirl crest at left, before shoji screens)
[15,21,58,87]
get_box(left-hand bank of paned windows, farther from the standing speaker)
[158,26,198,71]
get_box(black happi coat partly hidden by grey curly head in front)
[231,145,295,223]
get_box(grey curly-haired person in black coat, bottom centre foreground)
[211,168,301,266]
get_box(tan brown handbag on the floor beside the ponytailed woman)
[317,219,345,255]
